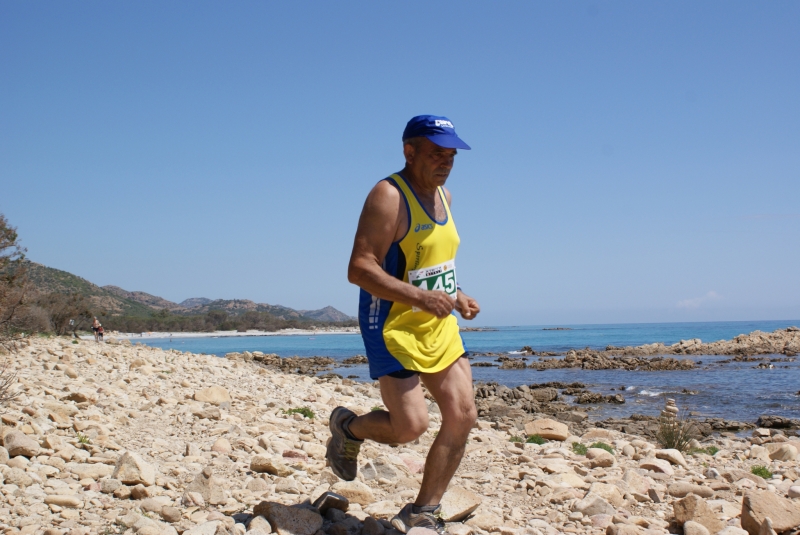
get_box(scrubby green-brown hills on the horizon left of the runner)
[26,262,355,321]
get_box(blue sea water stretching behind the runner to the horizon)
[131,320,800,422]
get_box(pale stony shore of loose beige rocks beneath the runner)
[0,338,800,535]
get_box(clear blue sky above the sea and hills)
[0,0,800,325]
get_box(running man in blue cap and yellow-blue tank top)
[326,115,480,533]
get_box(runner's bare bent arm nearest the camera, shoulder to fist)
[347,180,455,318]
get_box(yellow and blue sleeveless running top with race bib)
[358,173,466,379]
